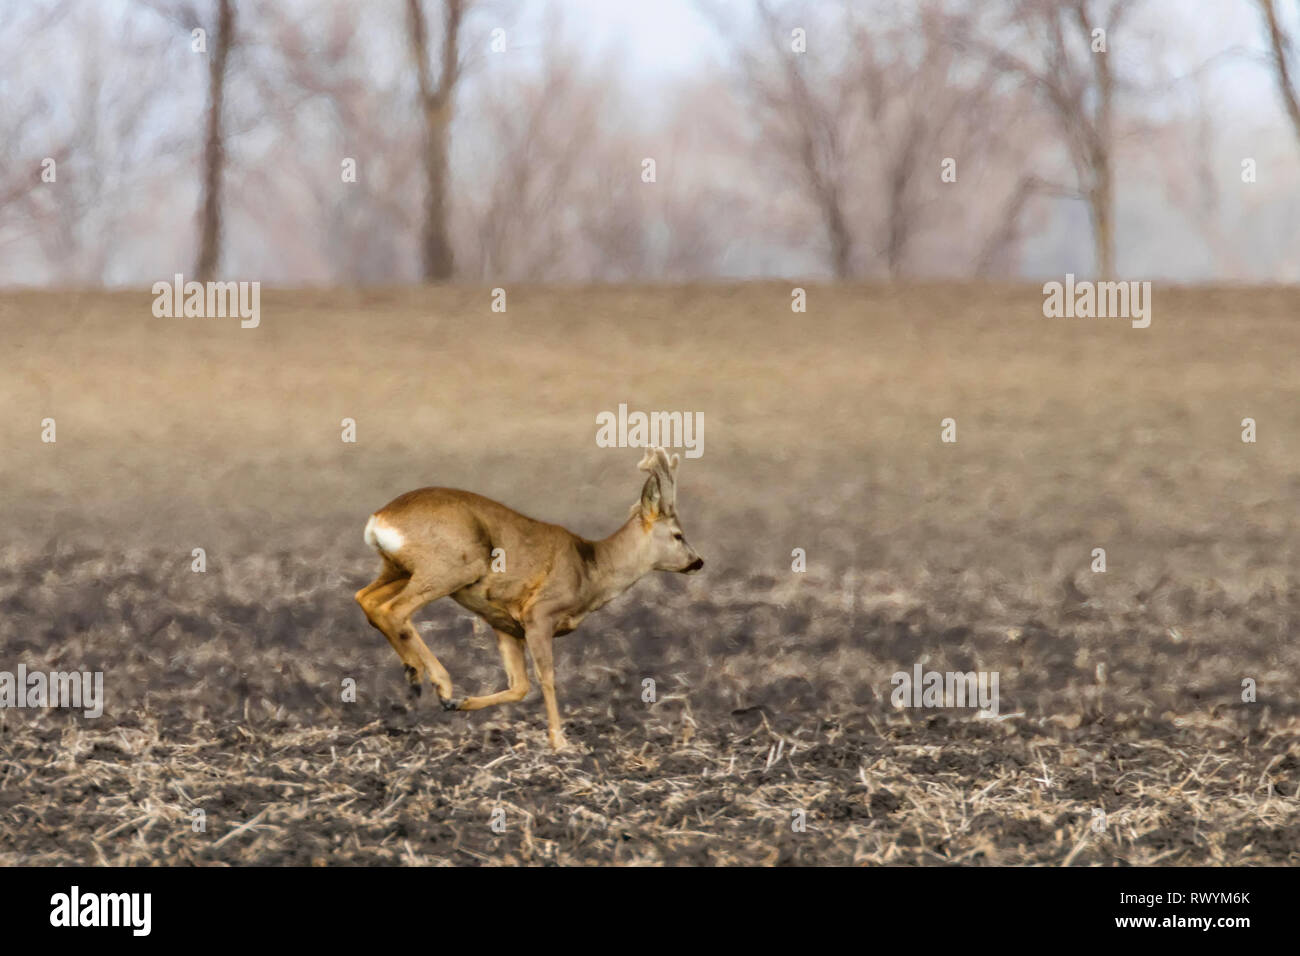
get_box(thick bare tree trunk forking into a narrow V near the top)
[407,0,467,281]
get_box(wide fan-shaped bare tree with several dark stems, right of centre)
[705,0,1015,278]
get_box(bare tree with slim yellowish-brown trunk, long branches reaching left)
[962,0,1138,276]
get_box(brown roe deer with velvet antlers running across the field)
[356,449,705,750]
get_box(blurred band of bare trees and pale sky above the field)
[0,0,1300,286]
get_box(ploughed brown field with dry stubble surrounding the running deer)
[0,278,1300,865]
